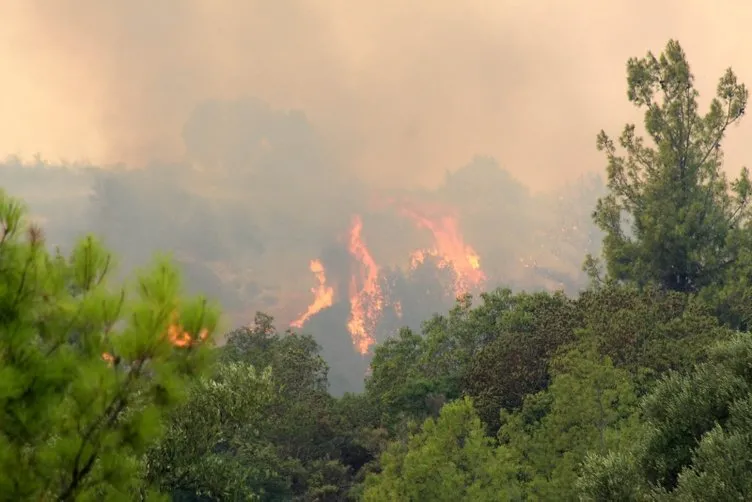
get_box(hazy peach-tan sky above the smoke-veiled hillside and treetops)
[0,0,752,188]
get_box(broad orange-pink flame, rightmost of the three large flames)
[401,207,486,296]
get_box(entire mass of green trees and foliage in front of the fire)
[0,41,752,502]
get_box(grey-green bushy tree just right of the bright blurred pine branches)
[147,363,291,501]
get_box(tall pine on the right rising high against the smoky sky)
[586,40,750,292]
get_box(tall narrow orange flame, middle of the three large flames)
[347,215,384,355]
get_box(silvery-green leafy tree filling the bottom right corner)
[579,333,752,501]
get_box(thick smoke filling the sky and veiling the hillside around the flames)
[0,0,752,387]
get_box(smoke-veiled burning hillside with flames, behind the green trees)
[0,150,600,393]
